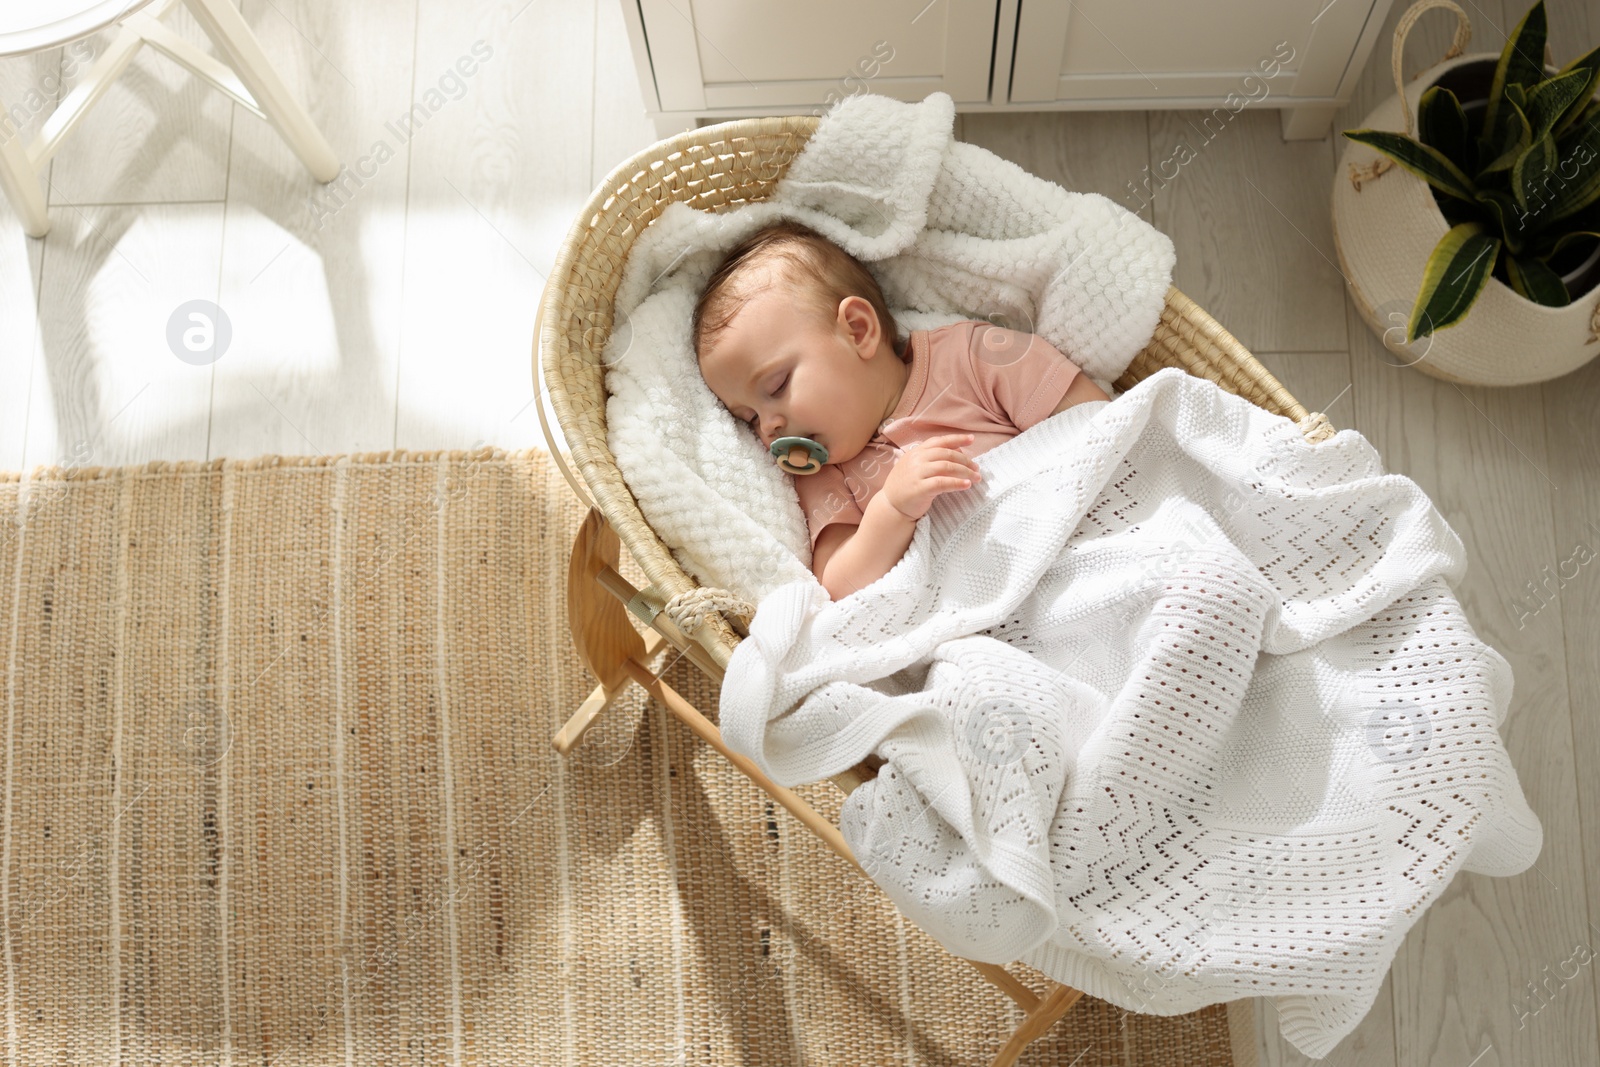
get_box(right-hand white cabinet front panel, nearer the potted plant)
[1010,0,1373,102]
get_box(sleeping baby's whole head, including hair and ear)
[694,219,909,462]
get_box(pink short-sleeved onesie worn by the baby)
[795,320,1078,549]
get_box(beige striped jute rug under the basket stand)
[0,450,1253,1067]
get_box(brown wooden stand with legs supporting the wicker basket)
[552,507,1083,1067]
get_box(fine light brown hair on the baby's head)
[693,219,898,357]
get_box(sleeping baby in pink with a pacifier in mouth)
[693,221,1107,600]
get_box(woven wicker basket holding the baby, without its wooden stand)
[533,115,1333,667]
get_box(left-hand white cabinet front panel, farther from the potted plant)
[638,0,998,110]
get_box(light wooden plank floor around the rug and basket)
[0,0,1600,1067]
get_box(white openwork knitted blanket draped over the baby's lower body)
[720,368,1542,1057]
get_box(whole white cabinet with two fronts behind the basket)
[619,0,1392,139]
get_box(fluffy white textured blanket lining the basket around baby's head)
[603,93,1174,603]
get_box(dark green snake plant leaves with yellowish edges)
[1344,0,1600,344]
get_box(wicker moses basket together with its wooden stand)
[533,115,1333,1067]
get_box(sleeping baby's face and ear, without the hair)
[701,288,904,464]
